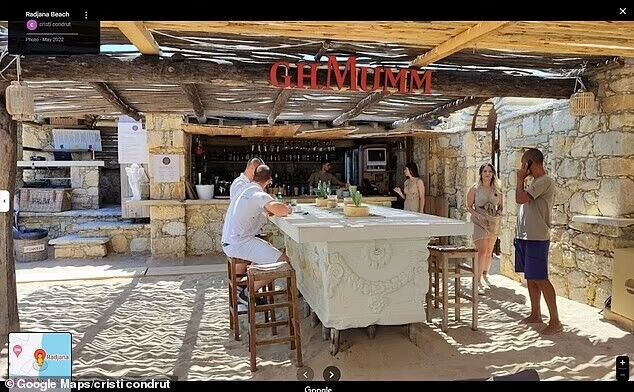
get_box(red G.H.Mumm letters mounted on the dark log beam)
[270,56,431,94]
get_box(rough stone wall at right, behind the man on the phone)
[414,59,634,307]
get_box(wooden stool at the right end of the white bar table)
[426,245,478,332]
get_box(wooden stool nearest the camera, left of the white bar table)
[247,263,303,372]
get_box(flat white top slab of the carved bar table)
[270,205,473,243]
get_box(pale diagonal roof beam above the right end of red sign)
[412,22,508,67]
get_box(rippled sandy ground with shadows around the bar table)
[0,274,634,380]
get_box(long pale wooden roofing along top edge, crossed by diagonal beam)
[101,20,634,57]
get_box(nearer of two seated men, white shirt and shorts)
[222,165,291,304]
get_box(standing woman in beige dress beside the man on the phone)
[467,163,504,294]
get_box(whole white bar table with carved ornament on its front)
[270,204,473,354]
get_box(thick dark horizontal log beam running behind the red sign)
[6,56,576,99]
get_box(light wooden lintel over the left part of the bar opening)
[183,124,300,138]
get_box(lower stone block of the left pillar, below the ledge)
[150,202,187,257]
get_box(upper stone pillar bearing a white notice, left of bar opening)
[145,113,186,200]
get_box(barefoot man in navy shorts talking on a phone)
[515,148,563,335]
